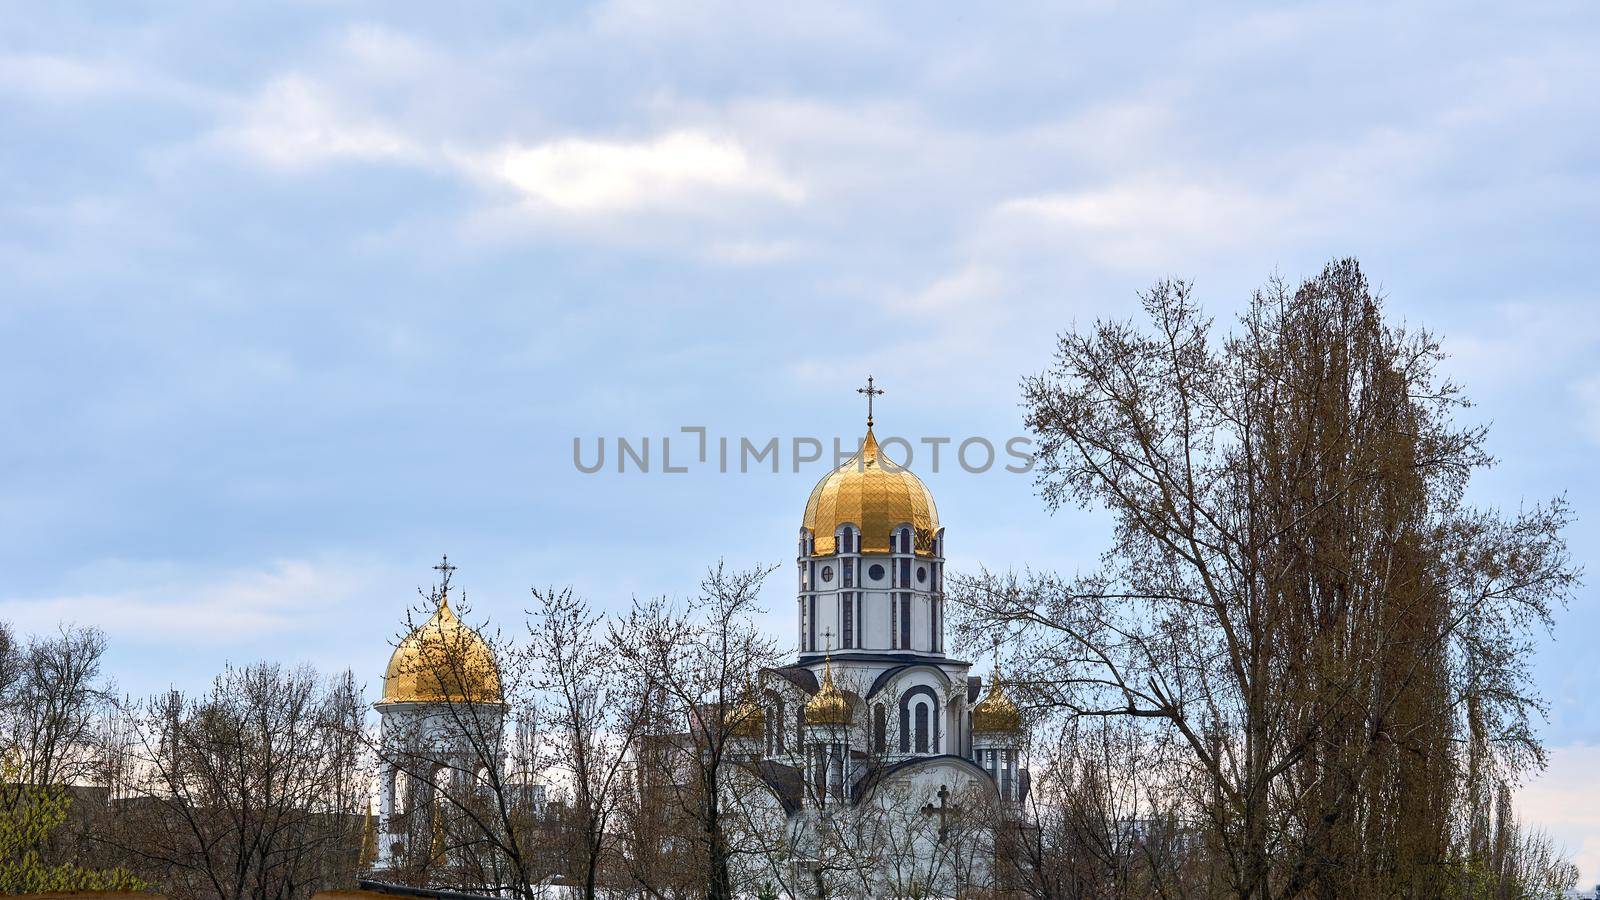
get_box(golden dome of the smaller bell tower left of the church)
[379,597,501,703]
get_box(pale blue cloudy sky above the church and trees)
[0,0,1600,884]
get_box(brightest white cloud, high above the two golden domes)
[480,131,805,215]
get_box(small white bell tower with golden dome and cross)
[374,557,506,870]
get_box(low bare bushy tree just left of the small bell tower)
[104,663,368,900]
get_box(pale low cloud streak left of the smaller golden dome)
[0,560,360,645]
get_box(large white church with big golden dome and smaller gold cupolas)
[713,403,1029,897]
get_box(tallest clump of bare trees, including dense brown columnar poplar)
[955,261,1576,897]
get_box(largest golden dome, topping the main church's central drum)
[802,424,939,556]
